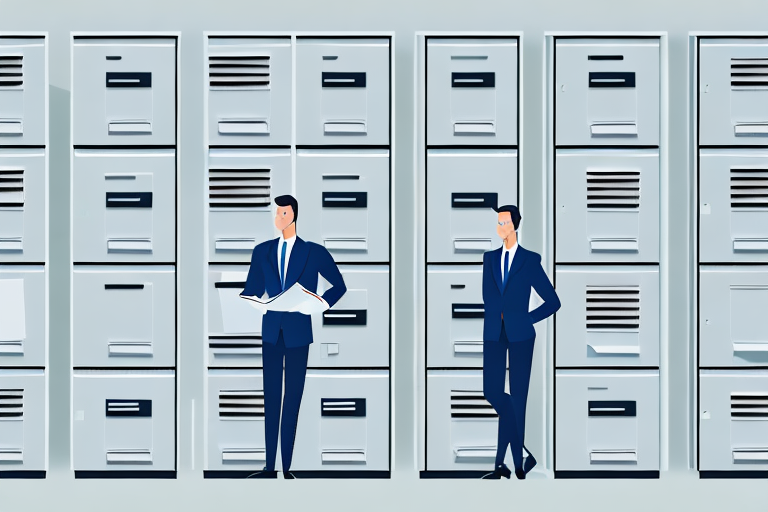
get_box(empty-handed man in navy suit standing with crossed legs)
[483,205,560,480]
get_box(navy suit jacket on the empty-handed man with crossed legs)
[483,245,560,342]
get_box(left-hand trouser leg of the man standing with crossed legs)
[483,328,522,468]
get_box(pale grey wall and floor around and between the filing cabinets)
[0,0,768,512]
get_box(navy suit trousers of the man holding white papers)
[262,329,309,471]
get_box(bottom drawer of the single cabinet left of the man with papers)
[72,370,176,472]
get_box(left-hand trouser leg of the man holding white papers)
[262,330,285,471]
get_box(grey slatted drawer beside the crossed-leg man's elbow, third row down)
[555,265,660,368]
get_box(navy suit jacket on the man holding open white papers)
[242,236,347,348]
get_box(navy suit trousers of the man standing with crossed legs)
[483,321,536,469]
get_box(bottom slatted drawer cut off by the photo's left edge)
[0,369,48,477]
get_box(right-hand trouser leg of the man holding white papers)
[280,345,309,471]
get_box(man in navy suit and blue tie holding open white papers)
[241,195,347,478]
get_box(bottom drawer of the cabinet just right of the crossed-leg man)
[555,368,659,471]
